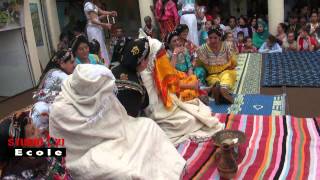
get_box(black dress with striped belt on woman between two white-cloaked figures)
[112,64,149,117]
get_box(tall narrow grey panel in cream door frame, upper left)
[29,0,50,70]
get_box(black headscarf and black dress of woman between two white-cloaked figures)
[112,39,149,117]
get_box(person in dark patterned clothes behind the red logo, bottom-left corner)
[0,111,71,180]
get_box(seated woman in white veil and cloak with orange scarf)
[139,30,224,144]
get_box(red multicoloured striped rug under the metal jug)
[177,114,320,179]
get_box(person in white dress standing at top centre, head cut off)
[178,0,199,46]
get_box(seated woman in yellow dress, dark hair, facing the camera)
[195,29,237,104]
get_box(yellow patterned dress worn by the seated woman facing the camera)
[196,43,237,90]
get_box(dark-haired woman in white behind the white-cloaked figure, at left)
[31,49,75,136]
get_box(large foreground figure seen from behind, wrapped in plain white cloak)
[49,64,185,179]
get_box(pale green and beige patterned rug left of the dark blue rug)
[233,53,262,94]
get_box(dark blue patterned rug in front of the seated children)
[262,52,320,87]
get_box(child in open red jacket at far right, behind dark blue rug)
[297,26,317,51]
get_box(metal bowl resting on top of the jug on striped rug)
[212,130,246,146]
